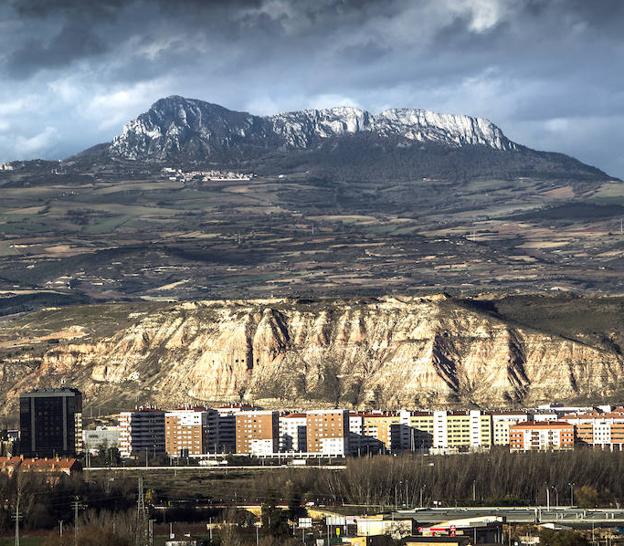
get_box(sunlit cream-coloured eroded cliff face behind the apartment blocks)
[2,297,624,412]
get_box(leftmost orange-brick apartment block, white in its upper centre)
[165,408,219,457]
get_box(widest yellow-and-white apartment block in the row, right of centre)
[433,410,492,453]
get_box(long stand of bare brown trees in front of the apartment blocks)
[233,450,624,508]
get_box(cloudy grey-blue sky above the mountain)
[0,0,624,178]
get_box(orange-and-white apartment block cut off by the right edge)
[561,410,624,451]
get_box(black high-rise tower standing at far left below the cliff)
[20,388,82,457]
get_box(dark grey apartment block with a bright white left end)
[119,408,165,458]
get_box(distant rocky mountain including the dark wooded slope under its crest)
[101,96,609,180]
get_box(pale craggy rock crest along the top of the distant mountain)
[110,95,518,160]
